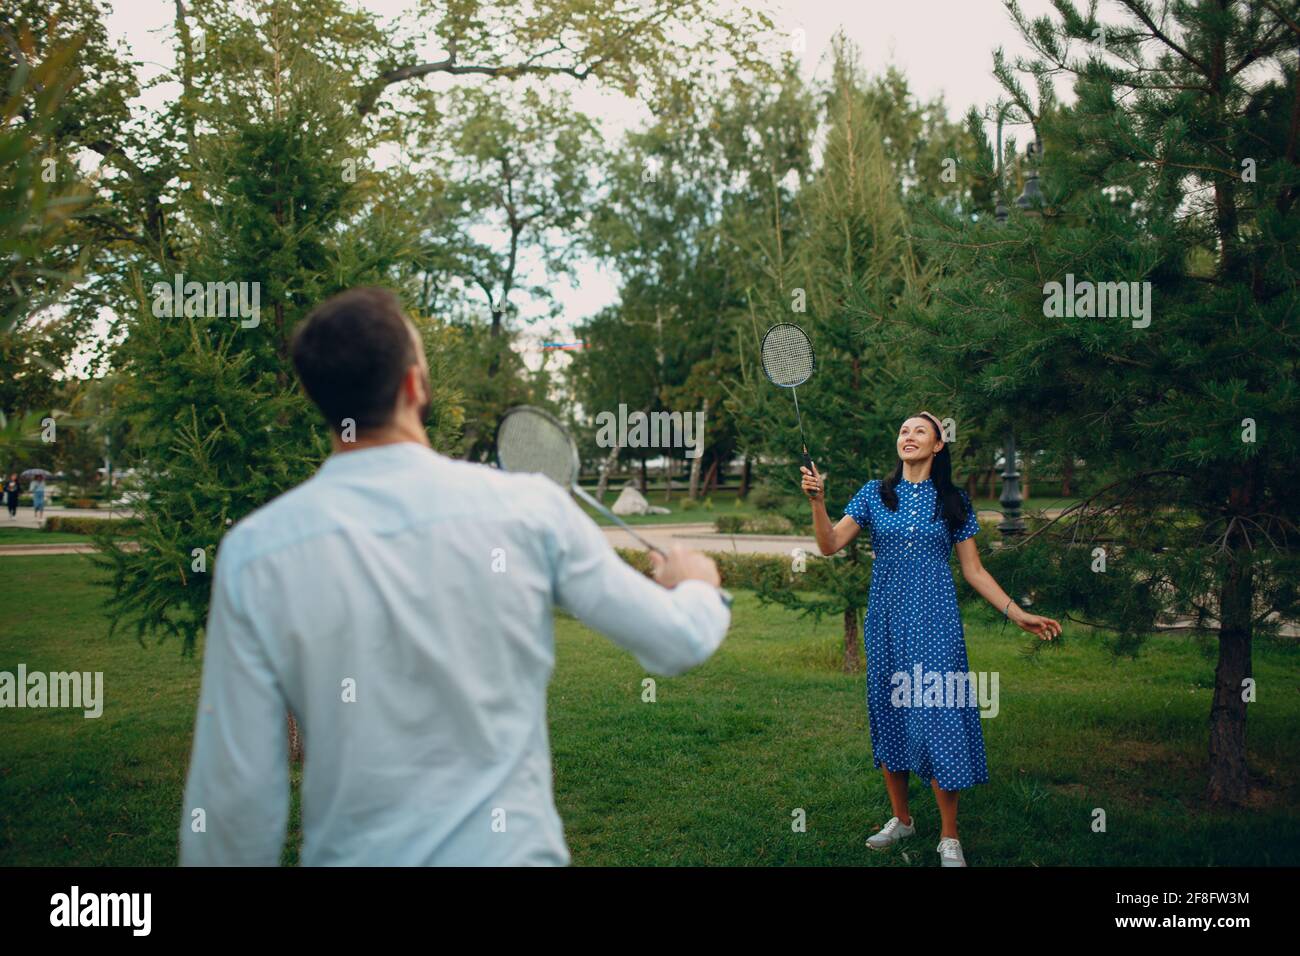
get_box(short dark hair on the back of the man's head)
[290,286,419,432]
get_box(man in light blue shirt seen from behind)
[181,287,731,866]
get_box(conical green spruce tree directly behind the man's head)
[101,35,460,650]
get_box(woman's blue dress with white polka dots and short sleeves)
[845,479,988,790]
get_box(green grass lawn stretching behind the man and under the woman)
[0,555,1300,866]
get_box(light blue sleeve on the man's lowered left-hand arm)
[181,546,289,866]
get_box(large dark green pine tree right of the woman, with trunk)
[901,0,1300,804]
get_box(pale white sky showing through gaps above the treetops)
[86,0,1050,364]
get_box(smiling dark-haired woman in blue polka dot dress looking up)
[801,411,1061,866]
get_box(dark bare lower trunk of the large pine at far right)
[1205,559,1253,805]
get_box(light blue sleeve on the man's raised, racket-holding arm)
[538,479,731,676]
